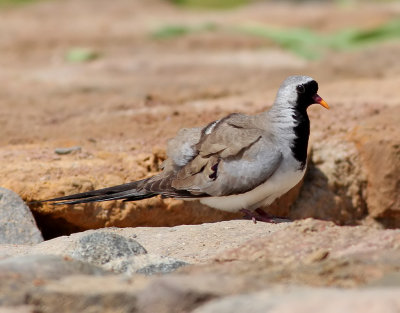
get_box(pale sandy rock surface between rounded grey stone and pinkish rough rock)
[112,220,287,264]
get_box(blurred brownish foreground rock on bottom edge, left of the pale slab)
[27,274,243,313]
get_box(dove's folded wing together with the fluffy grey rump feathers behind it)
[143,114,282,197]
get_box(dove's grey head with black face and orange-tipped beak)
[275,75,329,110]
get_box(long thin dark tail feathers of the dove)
[40,179,157,204]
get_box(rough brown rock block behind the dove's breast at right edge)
[289,106,400,228]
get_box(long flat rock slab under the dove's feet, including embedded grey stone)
[0,219,400,265]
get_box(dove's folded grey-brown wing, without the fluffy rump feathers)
[164,114,282,196]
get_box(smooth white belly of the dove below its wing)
[200,168,305,212]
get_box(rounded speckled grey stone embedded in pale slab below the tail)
[71,231,147,265]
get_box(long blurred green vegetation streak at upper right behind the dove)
[151,19,400,59]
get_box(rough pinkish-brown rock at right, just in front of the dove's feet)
[217,219,400,264]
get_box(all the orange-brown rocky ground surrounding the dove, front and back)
[0,0,400,312]
